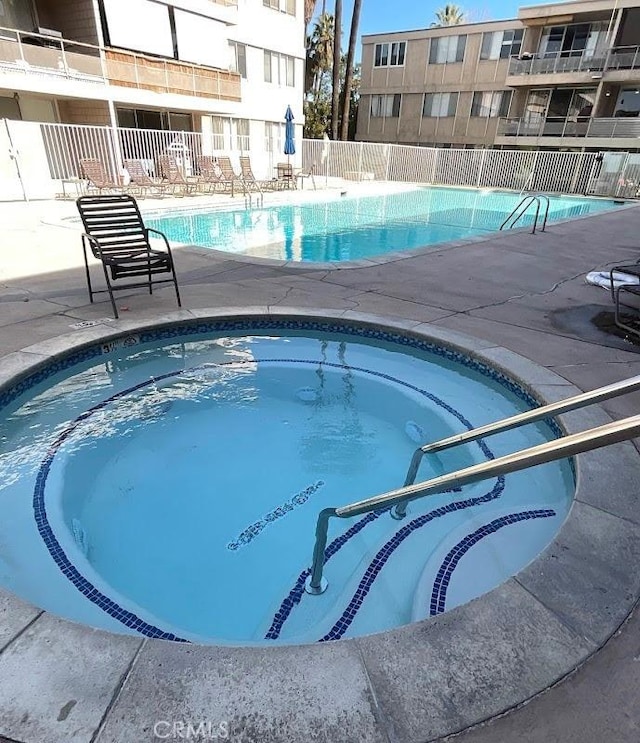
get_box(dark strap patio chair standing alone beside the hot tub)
[76,194,182,319]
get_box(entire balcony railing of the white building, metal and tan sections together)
[0,24,241,101]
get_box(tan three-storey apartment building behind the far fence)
[356,0,640,151]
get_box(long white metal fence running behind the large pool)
[0,120,640,200]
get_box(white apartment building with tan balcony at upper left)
[0,0,305,152]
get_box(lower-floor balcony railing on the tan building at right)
[498,116,640,139]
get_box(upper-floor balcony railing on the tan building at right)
[509,46,640,76]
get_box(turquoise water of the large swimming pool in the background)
[147,187,615,262]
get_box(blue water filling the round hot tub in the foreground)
[0,326,574,644]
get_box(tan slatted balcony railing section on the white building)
[105,49,240,101]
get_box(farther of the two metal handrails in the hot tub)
[391,374,640,519]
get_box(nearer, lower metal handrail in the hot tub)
[305,415,640,595]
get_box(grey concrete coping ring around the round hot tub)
[0,307,640,743]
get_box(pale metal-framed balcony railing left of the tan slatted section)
[0,28,104,83]
